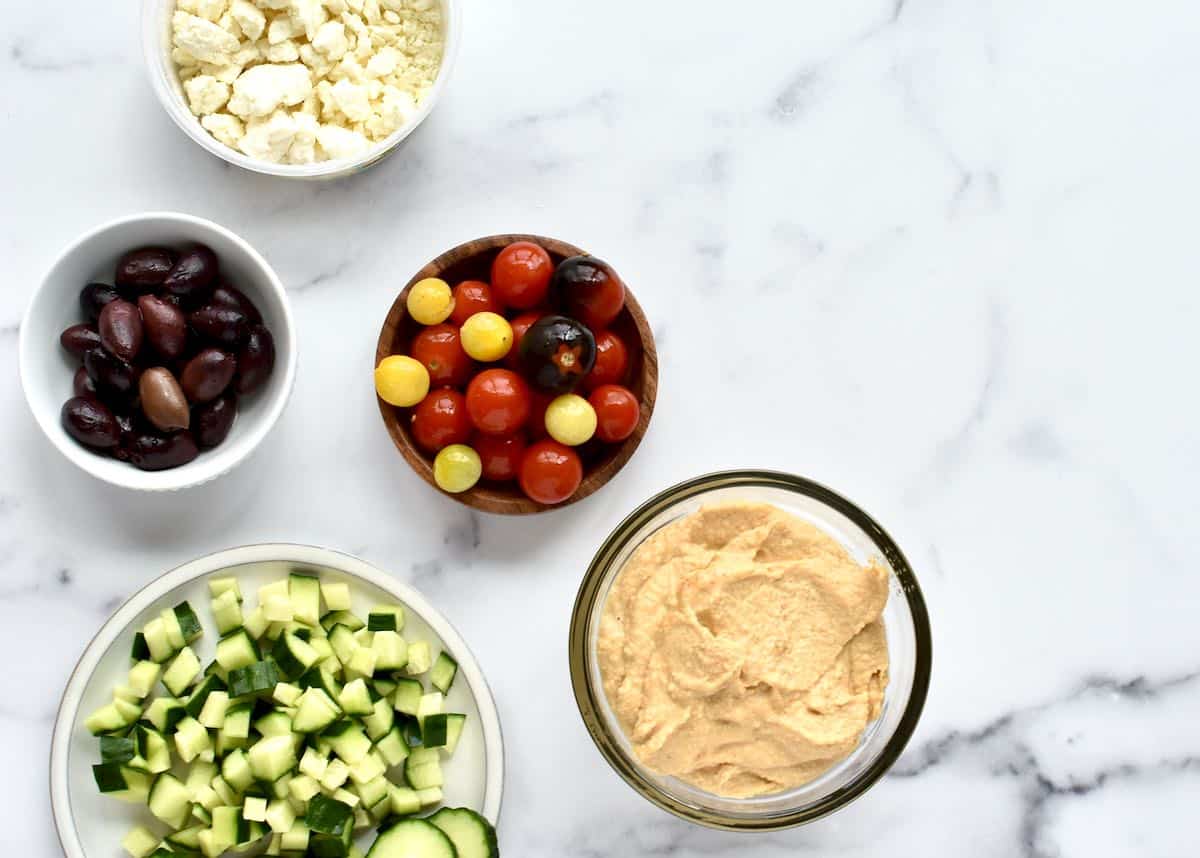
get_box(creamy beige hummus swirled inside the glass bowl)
[598,502,888,798]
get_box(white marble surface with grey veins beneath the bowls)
[0,0,1200,858]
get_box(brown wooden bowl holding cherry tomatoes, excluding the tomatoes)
[376,235,659,515]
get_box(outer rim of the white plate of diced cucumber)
[49,542,504,858]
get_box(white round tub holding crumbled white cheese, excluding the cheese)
[142,0,462,179]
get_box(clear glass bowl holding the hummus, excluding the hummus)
[570,470,932,832]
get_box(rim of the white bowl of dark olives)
[17,211,299,492]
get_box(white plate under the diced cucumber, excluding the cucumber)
[50,545,504,858]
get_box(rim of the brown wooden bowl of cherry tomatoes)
[372,233,659,515]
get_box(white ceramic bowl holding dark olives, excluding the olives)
[19,211,296,491]
